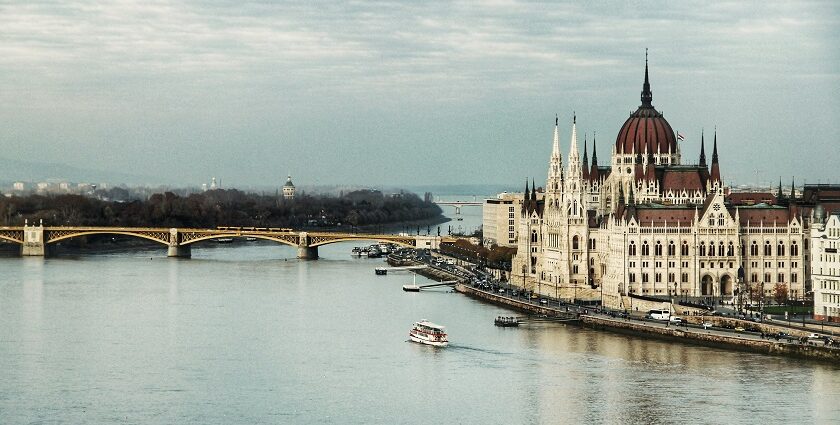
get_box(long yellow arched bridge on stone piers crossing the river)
[0,223,441,260]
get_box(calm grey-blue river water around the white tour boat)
[0,207,840,424]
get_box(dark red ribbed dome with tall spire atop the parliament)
[615,58,677,154]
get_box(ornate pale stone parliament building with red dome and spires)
[511,59,810,309]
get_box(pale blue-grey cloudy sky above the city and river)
[0,0,840,186]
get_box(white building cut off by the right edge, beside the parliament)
[811,206,840,322]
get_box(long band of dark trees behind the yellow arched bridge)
[0,189,442,229]
